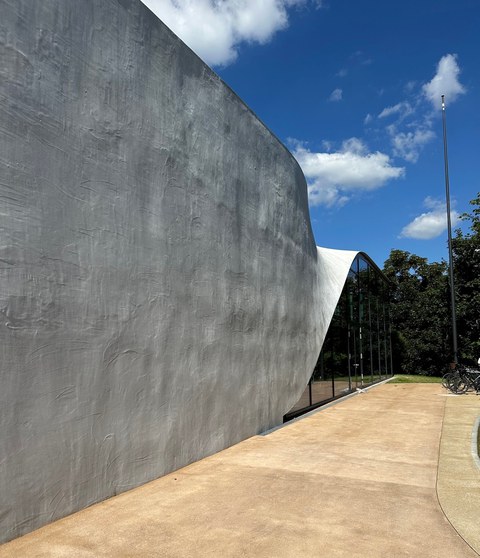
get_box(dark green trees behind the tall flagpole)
[384,194,480,374]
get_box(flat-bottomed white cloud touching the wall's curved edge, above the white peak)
[293,138,405,207]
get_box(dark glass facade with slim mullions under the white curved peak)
[285,254,392,420]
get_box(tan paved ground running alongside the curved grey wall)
[0,384,480,558]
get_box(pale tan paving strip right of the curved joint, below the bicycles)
[437,394,480,554]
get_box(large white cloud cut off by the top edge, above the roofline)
[142,0,321,66]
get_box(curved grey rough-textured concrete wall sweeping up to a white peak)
[0,0,355,541]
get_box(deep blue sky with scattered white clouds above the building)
[144,0,480,266]
